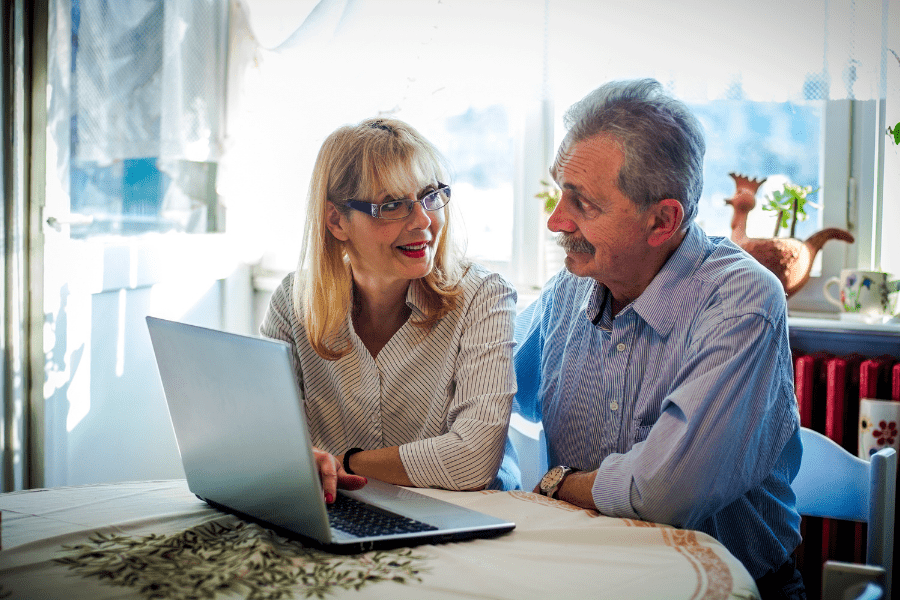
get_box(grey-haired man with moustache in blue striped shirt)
[515,80,805,598]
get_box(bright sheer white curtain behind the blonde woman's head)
[220,0,546,271]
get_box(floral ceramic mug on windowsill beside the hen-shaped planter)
[822,269,900,318]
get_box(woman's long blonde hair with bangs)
[293,118,465,360]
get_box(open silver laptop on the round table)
[147,317,515,553]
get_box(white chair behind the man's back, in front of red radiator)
[791,427,897,598]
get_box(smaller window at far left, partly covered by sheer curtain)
[49,0,226,239]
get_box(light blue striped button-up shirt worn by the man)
[514,225,801,578]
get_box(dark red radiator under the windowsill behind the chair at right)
[794,352,900,598]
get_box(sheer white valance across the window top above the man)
[550,0,890,102]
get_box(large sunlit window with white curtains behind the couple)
[236,0,900,310]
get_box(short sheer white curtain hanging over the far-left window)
[67,0,228,164]
